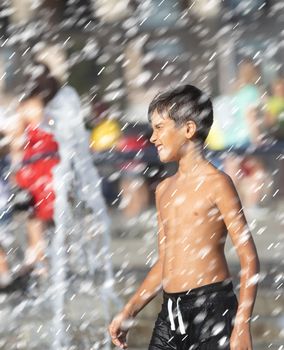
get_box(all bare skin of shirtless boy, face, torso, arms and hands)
[109,111,259,350]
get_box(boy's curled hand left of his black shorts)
[108,312,133,349]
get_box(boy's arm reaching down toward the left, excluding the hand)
[122,181,166,317]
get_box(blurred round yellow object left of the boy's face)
[90,119,122,152]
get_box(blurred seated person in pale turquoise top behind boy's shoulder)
[224,58,267,215]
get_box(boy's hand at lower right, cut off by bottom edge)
[230,323,253,350]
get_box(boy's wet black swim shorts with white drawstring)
[148,280,238,350]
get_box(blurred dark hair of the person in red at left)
[25,61,60,105]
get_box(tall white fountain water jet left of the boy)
[45,86,121,350]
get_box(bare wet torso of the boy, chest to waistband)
[157,170,230,292]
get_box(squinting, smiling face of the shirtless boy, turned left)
[150,110,187,163]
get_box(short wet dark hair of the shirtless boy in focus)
[148,85,213,143]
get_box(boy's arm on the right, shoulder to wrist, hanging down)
[215,174,259,324]
